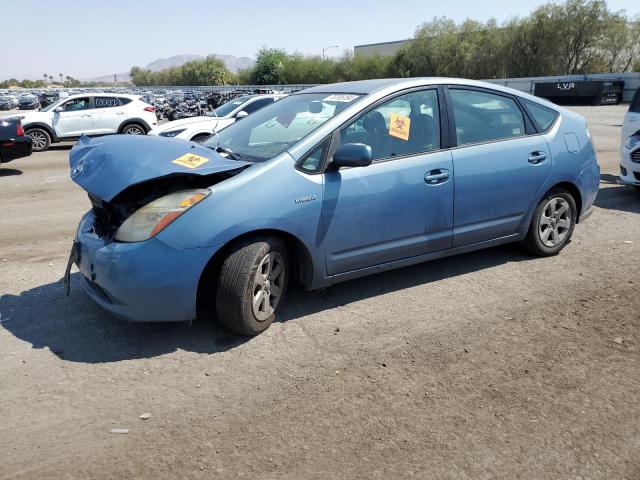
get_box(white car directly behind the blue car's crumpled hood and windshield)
[149,93,286,142]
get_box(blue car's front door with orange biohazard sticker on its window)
[320,89,454,275]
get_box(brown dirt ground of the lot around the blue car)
[0,106,640,480]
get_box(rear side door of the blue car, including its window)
[448,86,552,247]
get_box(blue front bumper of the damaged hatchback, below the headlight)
[76,211,217,322]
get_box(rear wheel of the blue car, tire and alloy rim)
[522,189,577,257]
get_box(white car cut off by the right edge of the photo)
[620,88,640,190]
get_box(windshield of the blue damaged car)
[204,93,360,162]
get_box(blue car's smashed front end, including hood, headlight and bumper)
[65,135,250,322]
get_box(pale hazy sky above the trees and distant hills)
[0,0,640,79]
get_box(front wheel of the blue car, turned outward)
[216,237,289,336]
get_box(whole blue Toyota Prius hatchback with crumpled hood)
[65,78,600,335]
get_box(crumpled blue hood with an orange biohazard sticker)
[69,135,250,202]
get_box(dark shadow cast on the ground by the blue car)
[0,246,533,363]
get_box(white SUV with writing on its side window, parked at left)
[21,93,158,152]
